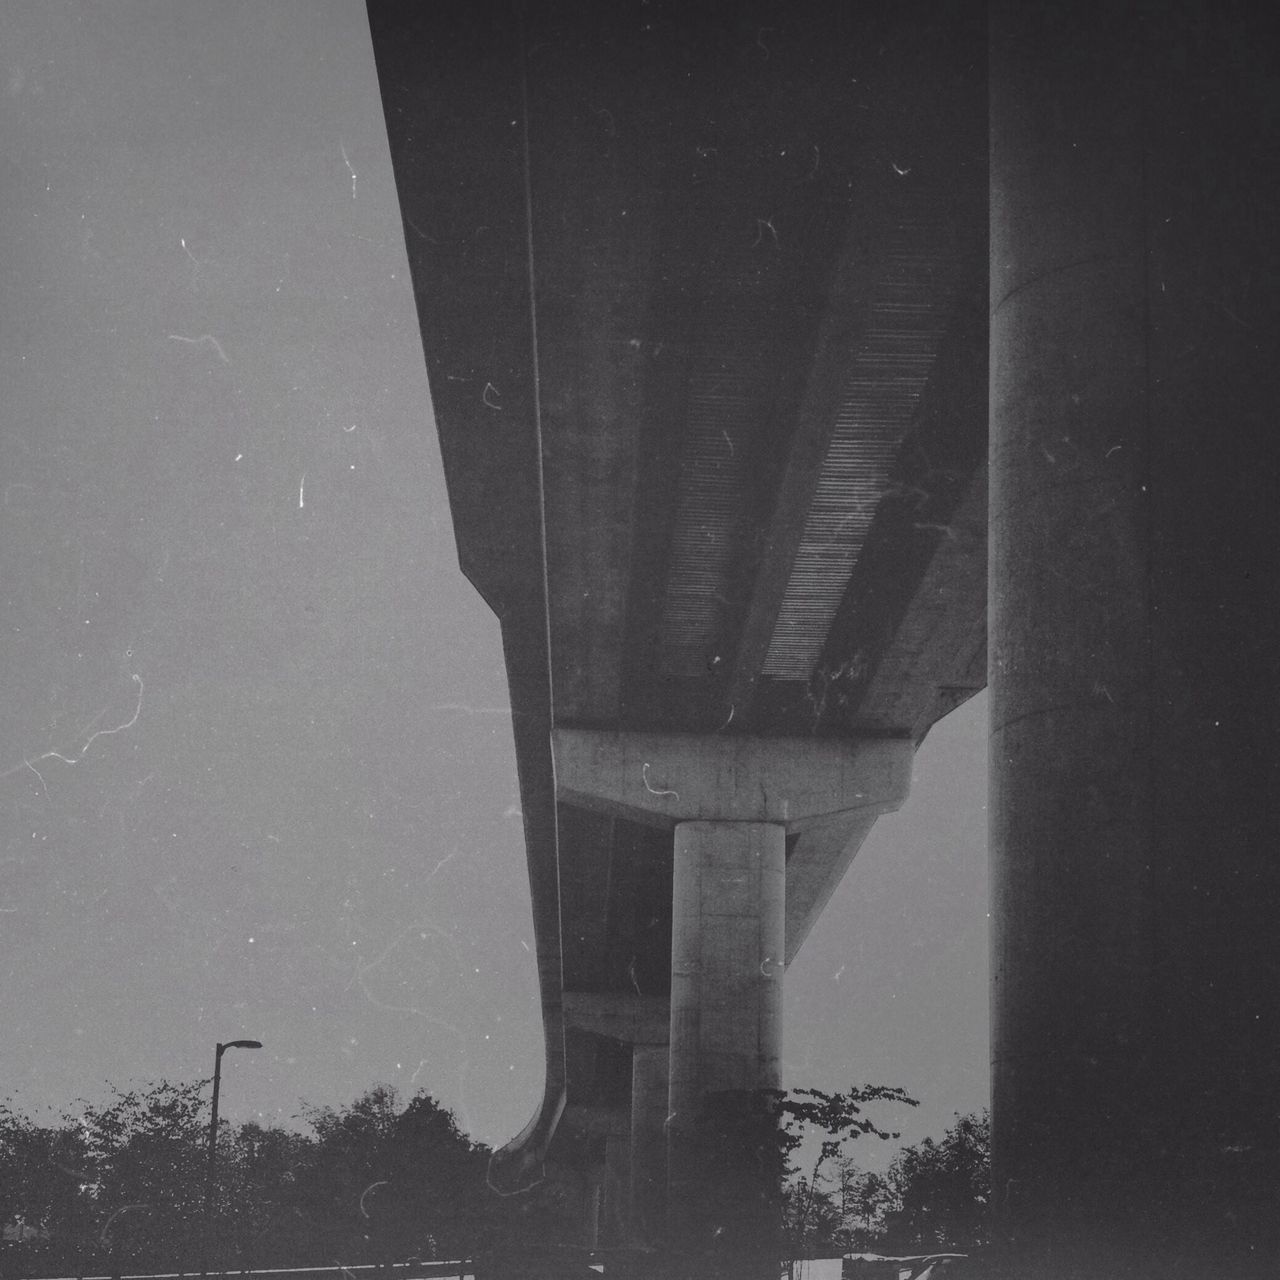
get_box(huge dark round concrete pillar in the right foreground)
[989,0,1280,1280]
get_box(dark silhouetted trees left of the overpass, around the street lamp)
[0,1080,489,1275]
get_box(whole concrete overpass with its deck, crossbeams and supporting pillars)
[370,0,1280,1277]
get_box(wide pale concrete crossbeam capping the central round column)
[552,727,914,832]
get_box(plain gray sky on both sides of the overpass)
[0,0,987,1162]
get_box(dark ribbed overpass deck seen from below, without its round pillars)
[371,3,987,1264]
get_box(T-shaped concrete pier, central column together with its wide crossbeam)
[553,726,914,1280]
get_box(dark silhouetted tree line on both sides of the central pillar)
[0,1082,987,1276]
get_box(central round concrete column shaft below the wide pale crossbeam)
[667,822,786,1276]
